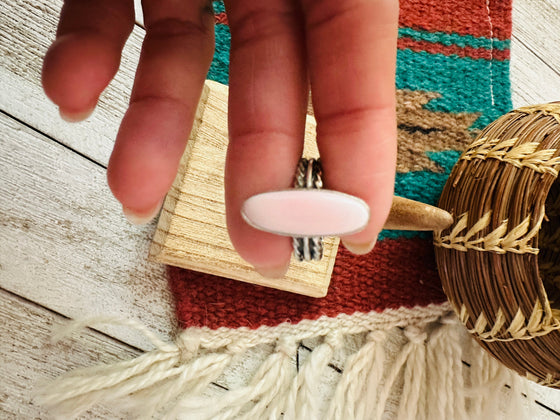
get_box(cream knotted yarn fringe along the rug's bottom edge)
[37,304,529,420]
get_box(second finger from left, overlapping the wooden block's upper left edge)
[108,0,214,217]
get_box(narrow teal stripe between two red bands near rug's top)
[399,28,511,50]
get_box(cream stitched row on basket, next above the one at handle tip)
[460,137,560,177]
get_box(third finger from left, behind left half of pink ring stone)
[225,0,308,277]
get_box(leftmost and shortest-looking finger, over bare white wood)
[42,0,134,121]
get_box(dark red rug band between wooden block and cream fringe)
[169,239,445,329]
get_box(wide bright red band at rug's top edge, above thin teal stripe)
[399,0,511,40]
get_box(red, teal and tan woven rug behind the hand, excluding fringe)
[169,0,511,329]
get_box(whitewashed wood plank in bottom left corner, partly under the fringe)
[0,289,140,419]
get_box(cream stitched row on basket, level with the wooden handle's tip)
[434,207,544,254]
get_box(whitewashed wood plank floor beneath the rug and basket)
[0,0,560,419]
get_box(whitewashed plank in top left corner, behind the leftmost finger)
[0,0,140,166]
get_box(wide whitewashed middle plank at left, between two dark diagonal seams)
[0,110,174,350]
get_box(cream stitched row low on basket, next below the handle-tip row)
[459,301,560,342]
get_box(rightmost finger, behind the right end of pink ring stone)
[303,0,398,253]
